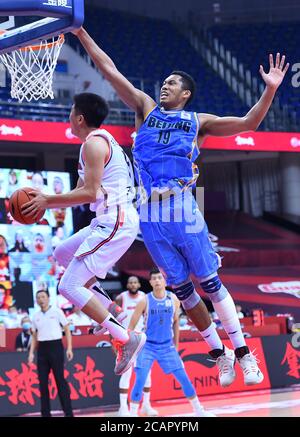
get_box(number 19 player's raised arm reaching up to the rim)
[74,28,155,117]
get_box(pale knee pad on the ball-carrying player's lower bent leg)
[58,270,94,309]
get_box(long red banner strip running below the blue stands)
[0,118,300,152]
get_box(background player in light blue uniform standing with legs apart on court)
[129,269,214,417]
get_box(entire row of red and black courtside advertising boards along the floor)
[0,333,300,417]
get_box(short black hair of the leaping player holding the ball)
[73,93,109,128]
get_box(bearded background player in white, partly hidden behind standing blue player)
[116,276,158,417]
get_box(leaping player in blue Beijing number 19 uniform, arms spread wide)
[76,28,289,386]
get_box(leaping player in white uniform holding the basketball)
[23,93,145,375]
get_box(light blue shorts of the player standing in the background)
[135,341,183,374]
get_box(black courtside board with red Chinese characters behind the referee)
[0,348,119,417]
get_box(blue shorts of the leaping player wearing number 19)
[139,191,220,285]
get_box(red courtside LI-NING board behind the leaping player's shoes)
[151,338,271,401]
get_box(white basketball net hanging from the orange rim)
[0,35,65,102]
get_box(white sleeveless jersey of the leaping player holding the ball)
[78,129,135,213]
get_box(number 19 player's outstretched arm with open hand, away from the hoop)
[199,53,289,137]
